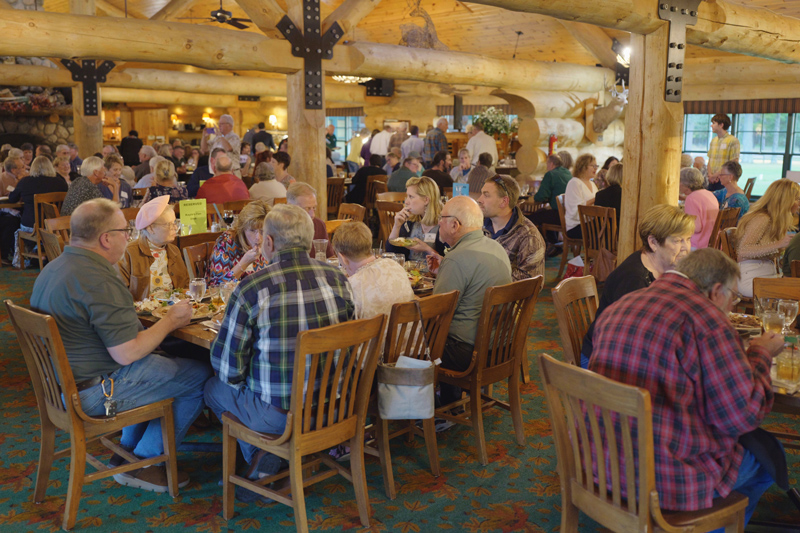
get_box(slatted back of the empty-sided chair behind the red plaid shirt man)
[539,355,655,531]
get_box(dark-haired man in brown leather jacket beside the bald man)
[478,174,545,281]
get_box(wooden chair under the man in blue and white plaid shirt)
[222,315,386,533]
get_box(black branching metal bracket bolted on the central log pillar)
[277,0,344,109]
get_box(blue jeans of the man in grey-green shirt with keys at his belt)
[80,354,213,458]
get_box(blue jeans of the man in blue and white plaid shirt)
[205,377,286,464]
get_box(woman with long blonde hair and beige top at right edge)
[734,179,800,298]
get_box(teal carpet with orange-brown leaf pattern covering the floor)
[0,259,800,533]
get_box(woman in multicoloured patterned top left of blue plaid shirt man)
[206,200,270,287]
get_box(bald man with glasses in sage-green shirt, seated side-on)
[427,196,512,410]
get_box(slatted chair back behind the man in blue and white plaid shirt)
[291,315,386,442]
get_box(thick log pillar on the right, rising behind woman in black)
[617,24,683,264]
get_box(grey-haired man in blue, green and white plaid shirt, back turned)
[205,205,354,490]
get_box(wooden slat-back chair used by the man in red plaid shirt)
[539,354,747,533]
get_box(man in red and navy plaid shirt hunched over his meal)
[589,248,783,523]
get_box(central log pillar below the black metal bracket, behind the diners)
[286,70,328,212]
